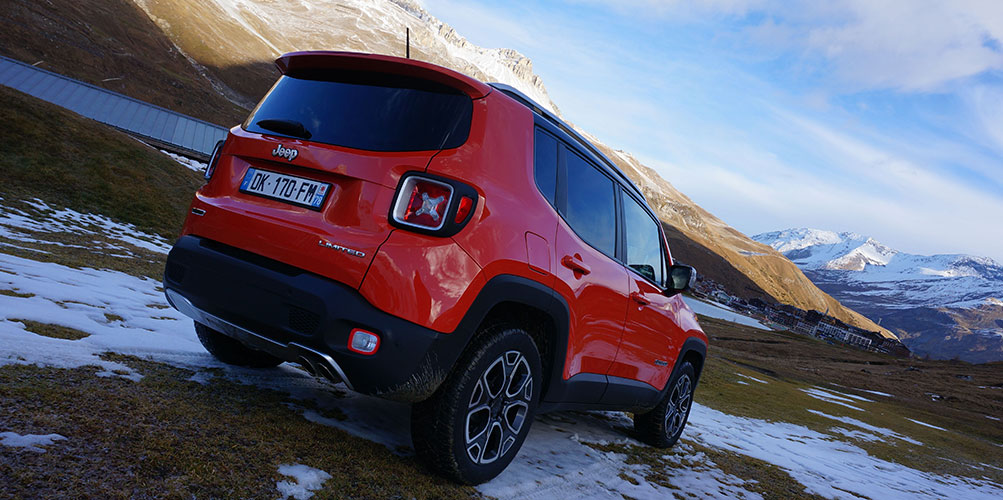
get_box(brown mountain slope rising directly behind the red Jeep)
[0,0,891,335]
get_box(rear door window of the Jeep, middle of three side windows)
[565,150,617,257]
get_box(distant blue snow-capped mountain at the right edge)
[752,228,1003,362]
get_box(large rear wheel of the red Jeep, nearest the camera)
[411,324,543,485]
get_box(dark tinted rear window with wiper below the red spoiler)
[243,71,473,151]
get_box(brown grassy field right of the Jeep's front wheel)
[696,318,1003,484]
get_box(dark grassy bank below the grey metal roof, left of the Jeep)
[0,87,202,239]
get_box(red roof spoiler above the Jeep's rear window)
[275,50,491,99]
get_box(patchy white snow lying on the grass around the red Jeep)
[0,197,1003,499]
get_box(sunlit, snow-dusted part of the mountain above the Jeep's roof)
[133,0,559,112]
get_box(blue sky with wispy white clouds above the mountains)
[421,0,1003,262]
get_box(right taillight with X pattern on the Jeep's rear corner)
[390,172,477,236]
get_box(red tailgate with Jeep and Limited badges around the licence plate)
[187,128,434,288]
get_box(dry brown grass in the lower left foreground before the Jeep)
[0,356,476,499]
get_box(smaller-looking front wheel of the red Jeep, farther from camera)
[634,361,696,448]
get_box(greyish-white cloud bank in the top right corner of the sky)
[576,0,1003,91]
